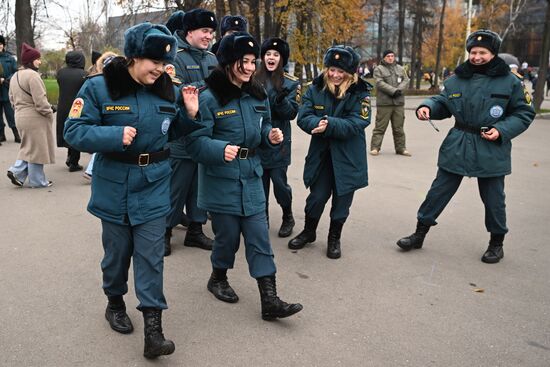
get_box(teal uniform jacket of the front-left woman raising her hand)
[64,58,193,226]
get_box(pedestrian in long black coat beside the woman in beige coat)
[56,51,87,172]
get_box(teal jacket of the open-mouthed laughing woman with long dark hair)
[260,74,300,169]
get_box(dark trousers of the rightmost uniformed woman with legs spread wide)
[417,168,508,234]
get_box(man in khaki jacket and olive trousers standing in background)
[370,50,412,157]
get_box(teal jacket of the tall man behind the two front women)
[170,31,218,159]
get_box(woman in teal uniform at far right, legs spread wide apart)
[397,29,535,264]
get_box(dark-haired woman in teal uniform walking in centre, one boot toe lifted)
[187,32,302,320]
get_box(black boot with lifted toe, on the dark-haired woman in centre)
[257,275,304,321]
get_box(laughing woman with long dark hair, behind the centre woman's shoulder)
[257,38,300,237]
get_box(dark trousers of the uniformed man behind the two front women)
[166,158,206,228]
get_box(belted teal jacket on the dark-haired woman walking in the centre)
[186,70,271,216]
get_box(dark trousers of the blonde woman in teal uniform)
[305,155,354,223]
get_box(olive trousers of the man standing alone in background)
[370,106,407,153]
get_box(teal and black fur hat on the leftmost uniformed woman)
[124,22,177,62]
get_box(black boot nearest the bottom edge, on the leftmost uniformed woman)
[142,308,176,358]
